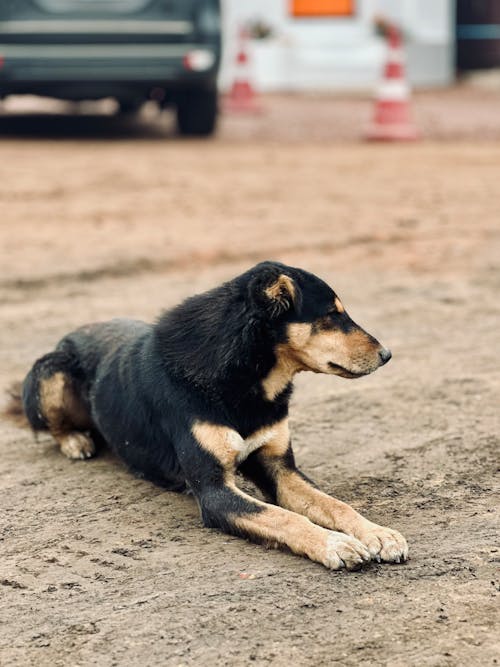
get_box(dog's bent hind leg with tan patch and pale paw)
[22,351,95,459]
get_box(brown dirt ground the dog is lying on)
[0,90,500,667]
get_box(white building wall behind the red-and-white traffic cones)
[221,0,454,91]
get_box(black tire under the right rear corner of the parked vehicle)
[177,88,218,137]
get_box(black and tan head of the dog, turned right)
[249,262,391,378]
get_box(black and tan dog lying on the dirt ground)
[7,262,408,569]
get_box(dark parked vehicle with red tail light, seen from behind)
[0,0,221,135]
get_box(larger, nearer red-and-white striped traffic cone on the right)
[365,25,419,141]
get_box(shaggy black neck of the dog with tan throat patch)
[154,295,303,404]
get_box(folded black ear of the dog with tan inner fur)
[251,270,302,318]
